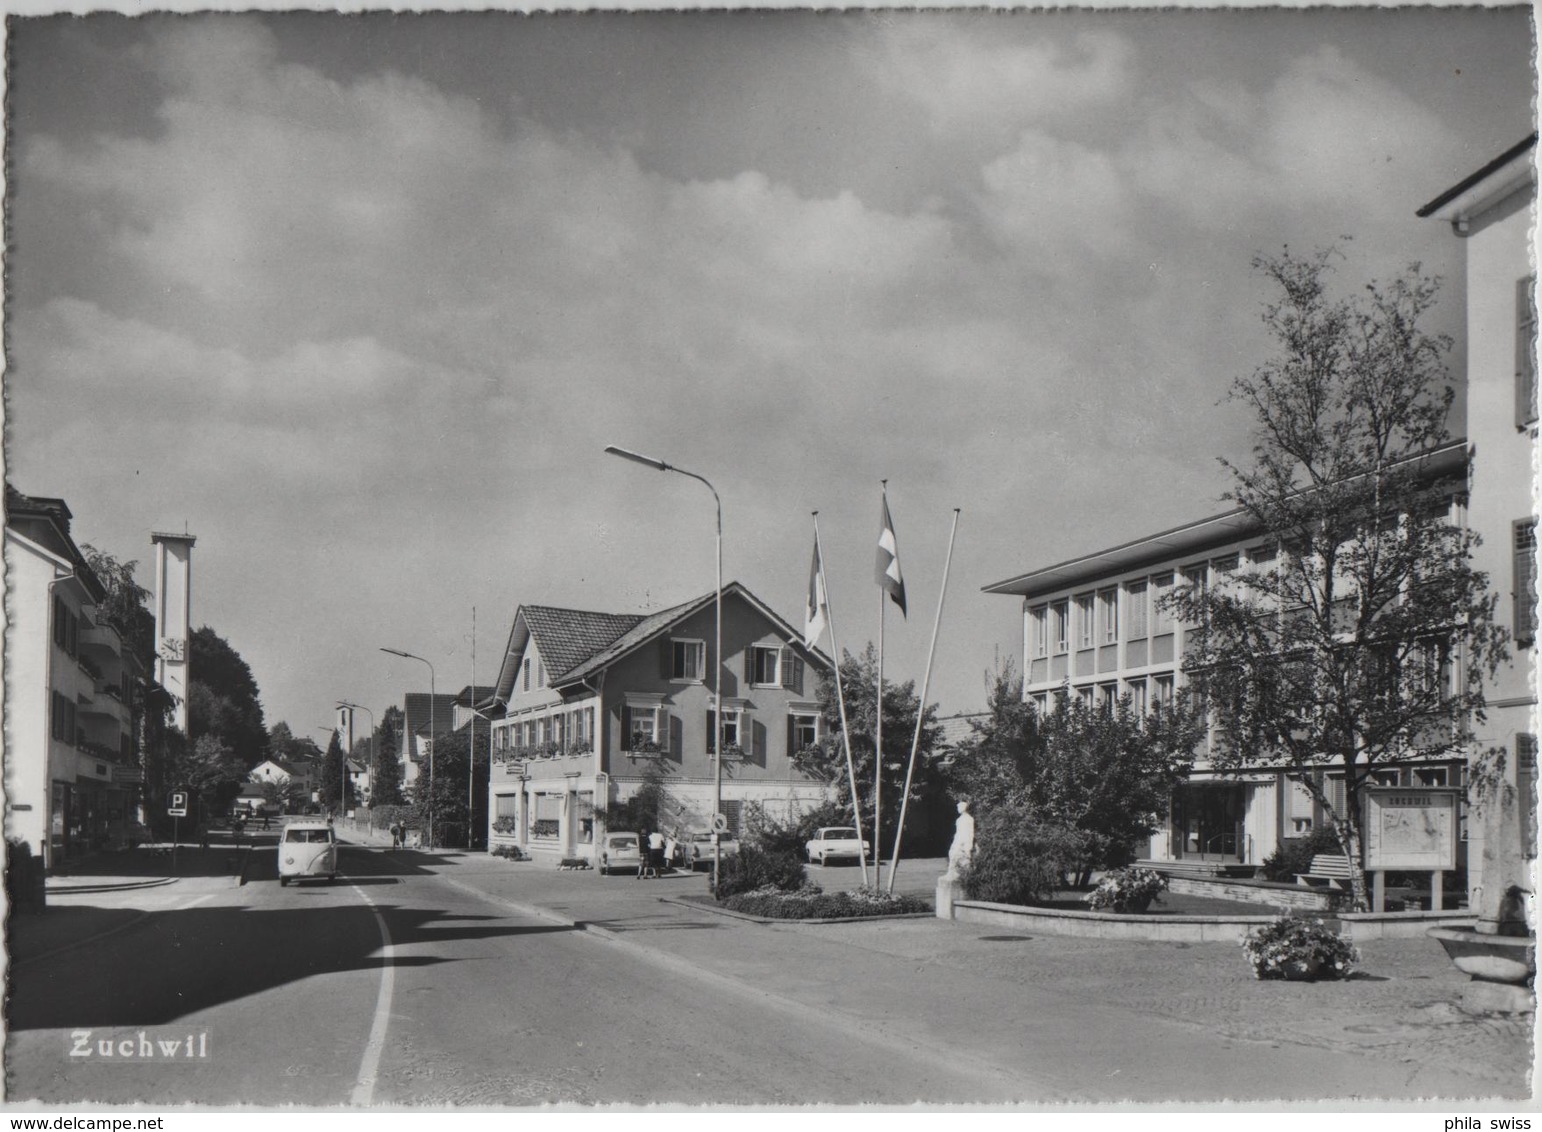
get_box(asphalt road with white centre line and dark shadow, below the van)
[6,848,1041,1106]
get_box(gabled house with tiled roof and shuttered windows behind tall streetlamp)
[487,583,830,857]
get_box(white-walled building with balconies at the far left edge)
[5,484,145,868]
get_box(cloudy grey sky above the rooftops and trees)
[6,8,1533,746]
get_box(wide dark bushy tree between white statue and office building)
[948,662,1204,882]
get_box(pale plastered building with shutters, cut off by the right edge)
[1419,134,1537,906]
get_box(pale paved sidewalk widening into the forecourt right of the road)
[397,851,1533,1100]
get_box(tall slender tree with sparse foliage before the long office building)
[1169,248,1507,908]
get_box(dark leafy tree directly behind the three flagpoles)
[793,643,951,854]
